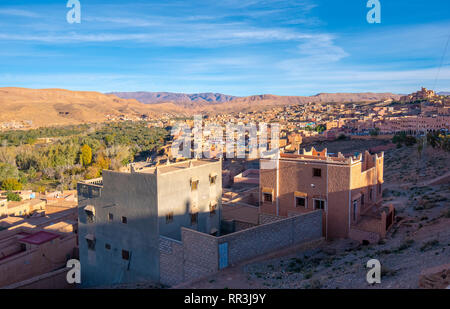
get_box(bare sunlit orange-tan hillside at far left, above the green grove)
[0,88,163,126]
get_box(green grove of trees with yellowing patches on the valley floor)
[0,122,168,200]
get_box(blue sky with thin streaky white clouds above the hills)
[0,0,450,96]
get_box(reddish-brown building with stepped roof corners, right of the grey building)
[260,148,394,242]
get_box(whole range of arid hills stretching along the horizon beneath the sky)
[0,88,400,127]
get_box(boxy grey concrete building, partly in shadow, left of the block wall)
[77,160,222,286]
